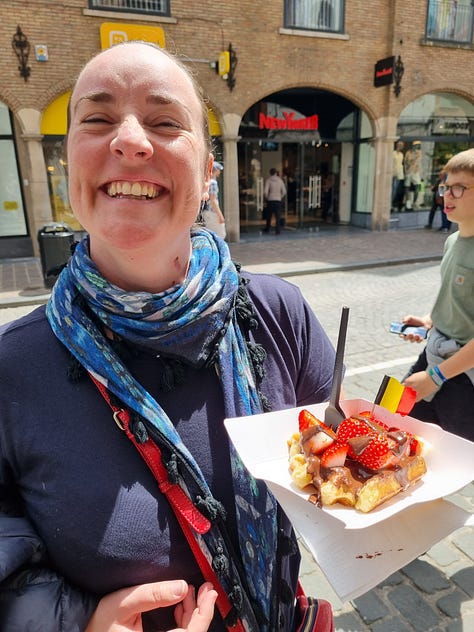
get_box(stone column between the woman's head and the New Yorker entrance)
[221,114,241,242]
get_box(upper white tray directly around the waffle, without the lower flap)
[225,399,474,529]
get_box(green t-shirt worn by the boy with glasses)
[431,232,474,345]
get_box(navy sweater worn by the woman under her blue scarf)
[0,274,334,632]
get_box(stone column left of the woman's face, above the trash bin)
[17,109,53,256]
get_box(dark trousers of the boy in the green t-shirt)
[407,351,474,441]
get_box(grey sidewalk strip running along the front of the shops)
[0,226,446,306]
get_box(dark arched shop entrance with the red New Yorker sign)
[238,89,360,233]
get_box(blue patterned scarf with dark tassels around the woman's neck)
[47,229,277,631]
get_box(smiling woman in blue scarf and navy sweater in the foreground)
[0,42,334,632]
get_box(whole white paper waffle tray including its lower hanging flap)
[225,399,474,601]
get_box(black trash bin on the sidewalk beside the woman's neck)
[38,222,75,287]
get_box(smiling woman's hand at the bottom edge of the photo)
[85,580,217,632]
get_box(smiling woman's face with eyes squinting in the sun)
[67,43,210,256]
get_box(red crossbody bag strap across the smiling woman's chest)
[89,373,245,632]
